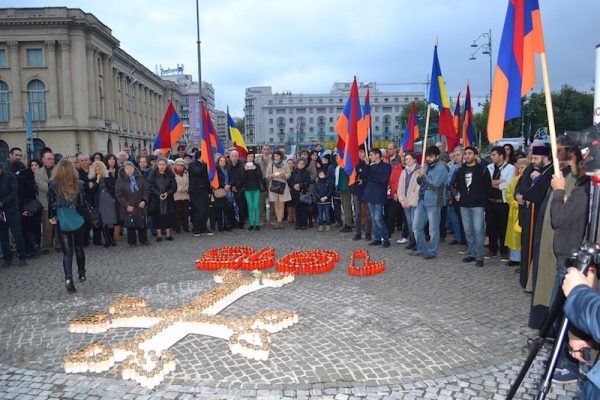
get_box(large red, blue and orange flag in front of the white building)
[335,77,366,185]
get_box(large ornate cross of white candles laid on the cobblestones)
[63,268,298,388]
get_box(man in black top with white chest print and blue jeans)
[454,146,491,267]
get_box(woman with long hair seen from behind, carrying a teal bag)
[48,159,88,293]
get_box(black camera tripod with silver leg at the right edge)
[506,171,600,400]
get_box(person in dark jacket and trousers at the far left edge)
[0,163,27,268]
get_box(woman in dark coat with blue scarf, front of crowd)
[115,161,148,246]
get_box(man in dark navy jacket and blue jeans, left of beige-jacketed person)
[359,149,392,247]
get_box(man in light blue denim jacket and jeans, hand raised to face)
[411,146,448,260]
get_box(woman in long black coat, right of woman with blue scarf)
[149,158,177,242]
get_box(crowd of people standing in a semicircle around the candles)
[0,136,590,394]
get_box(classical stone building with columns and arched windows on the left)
[0,7,182,159]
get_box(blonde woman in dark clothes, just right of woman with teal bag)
[88,161,117,248]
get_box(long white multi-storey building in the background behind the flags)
[244,82,425,147]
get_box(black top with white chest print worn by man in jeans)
[458,163,492,208]
